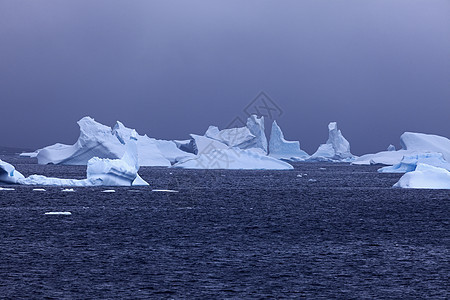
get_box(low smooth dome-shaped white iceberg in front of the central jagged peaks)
[172,148,293,170]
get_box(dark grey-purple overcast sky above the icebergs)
[0,0,450,154]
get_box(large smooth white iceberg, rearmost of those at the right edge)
[352,132,450,165]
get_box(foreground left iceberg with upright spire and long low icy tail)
[0,131,148,186]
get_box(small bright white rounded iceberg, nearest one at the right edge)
[393,163,450,189]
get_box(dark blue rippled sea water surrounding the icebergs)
[0,154,450,299]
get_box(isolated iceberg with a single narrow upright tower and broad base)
[307,122,355,162]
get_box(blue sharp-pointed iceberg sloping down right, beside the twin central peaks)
[269,121,309,161]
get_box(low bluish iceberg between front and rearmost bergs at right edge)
[378,152,450,173]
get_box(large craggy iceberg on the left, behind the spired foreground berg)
[31,117,191,167]
